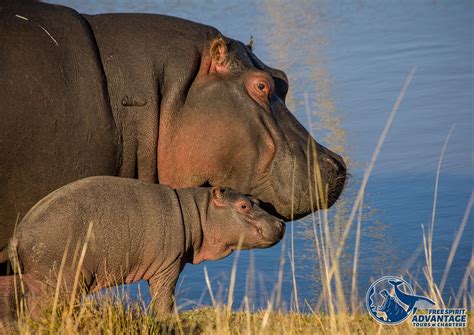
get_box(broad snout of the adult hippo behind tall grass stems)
[252,98,347,220]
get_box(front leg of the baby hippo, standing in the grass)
[148,264,182,316]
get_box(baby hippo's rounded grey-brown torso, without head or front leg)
[12,176,185,287]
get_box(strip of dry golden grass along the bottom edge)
[0,299,474,335]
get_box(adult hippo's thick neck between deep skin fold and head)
[84,14,219,182]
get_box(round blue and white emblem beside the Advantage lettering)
[365,276,416,325]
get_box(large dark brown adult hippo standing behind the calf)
[0,0,346,270]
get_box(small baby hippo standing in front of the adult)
[4,177,285,313]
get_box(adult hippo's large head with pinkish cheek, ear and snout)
[158,37,346,220]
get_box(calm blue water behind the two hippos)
[49,0,474,309]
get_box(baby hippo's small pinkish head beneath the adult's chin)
[195,187,285,263]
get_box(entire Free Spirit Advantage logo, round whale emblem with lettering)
[365,276,467,328]
